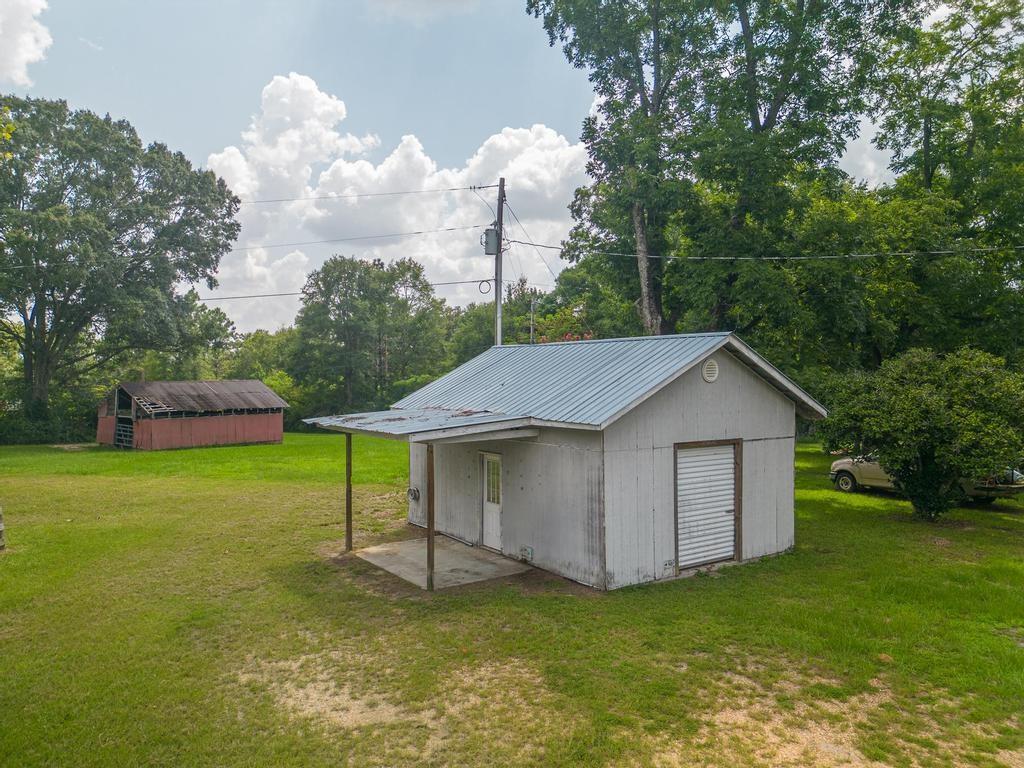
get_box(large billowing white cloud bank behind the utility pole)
[208,73,587,331]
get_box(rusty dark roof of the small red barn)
[119,379,288,414]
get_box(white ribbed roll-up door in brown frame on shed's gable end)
[676,444,736,568]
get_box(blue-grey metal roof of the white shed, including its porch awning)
[308,333,826,439]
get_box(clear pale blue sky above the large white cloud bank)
[18,0,592,165]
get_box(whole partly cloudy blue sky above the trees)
[0,0,888,331]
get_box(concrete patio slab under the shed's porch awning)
[355,536,529,589]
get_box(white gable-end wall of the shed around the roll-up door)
[604,350,796,589]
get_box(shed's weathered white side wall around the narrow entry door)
[409,429,604,586]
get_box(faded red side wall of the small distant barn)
[134,413,285,451]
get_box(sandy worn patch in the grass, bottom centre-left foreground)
[239,650,569,765]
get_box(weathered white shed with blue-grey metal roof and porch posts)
[308,333,825,589]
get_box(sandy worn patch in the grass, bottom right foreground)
[648,666,1011,768]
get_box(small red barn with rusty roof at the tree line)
[96,379,288,451]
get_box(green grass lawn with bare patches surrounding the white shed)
[0,435,1024,767]
